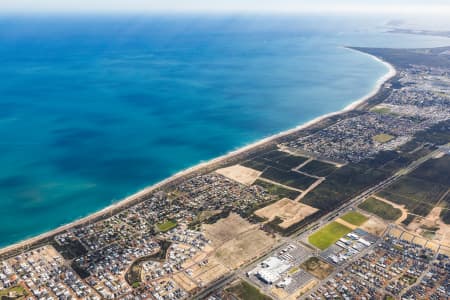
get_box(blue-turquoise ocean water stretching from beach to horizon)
[0,16,449,246]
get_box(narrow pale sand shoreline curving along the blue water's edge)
[0,47,397,255]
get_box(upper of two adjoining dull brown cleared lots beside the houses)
[202,213,256,247]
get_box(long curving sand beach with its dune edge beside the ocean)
[0,47,397,259]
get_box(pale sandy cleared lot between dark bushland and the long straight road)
[255,198,318,228]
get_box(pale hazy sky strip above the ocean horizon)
[0,0,450,16]
